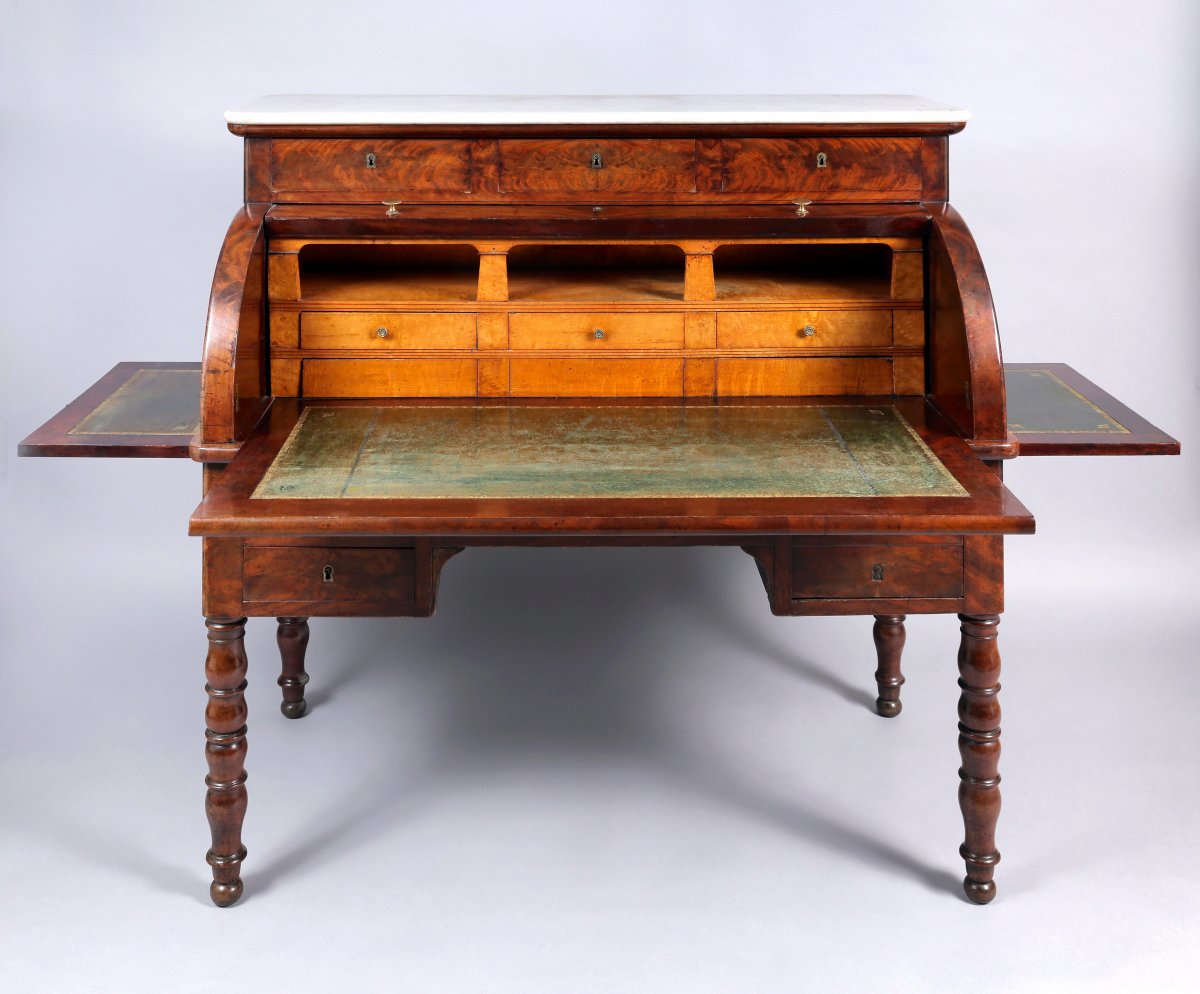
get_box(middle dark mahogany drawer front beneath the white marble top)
[499,138,696,193]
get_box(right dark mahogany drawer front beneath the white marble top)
[721,138,922,200]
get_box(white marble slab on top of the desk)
[226,94,971,125]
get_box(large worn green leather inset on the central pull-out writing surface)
[252,406,966,499]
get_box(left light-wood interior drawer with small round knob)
[300,311,475,349]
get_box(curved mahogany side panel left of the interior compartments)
[200,204,268,444]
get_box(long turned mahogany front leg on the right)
[959,615,1000,904]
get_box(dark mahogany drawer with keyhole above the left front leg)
[242,546,416,610]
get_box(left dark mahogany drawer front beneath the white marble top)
[271,138,470,199]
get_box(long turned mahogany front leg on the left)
[204,618,246,908]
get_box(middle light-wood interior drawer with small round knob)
[509,312,683,353]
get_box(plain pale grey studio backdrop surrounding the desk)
[0,0,1200,994]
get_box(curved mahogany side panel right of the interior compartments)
[928,204,1008,447]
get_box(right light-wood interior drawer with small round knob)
[716,311,892,348]
